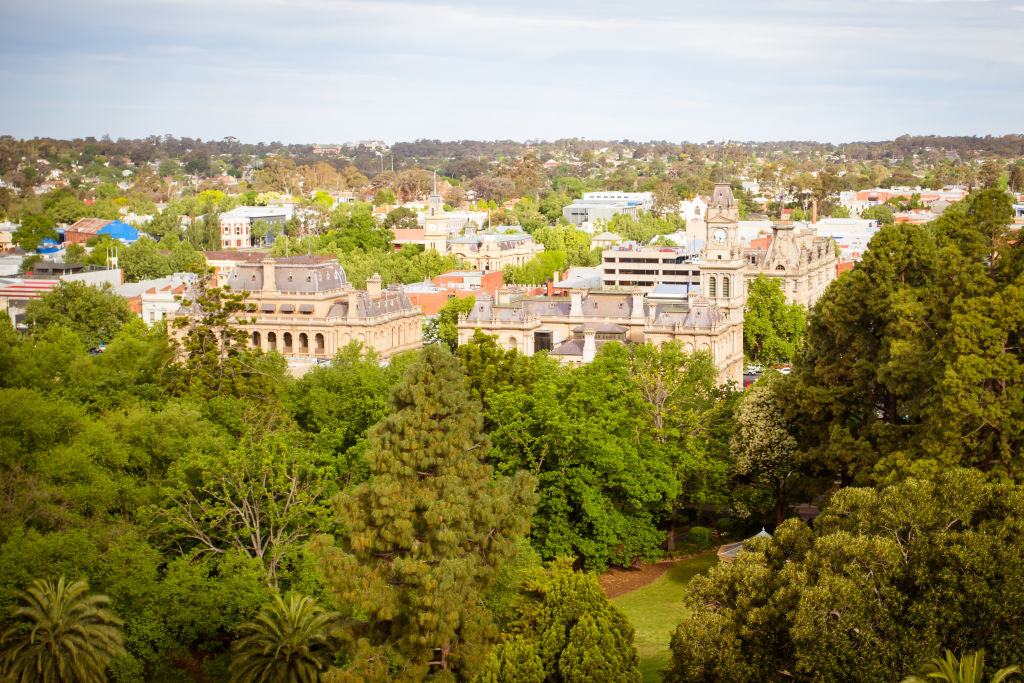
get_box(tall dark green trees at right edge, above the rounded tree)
[781,190,1024,483]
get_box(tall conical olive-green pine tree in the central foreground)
[321,345,534,679]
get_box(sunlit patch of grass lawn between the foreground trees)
[611,552,718,683]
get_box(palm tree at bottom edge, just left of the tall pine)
[230,594,340,683]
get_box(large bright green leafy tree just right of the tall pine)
[486,343,679,569]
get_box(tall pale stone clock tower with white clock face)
[700,182,746,319]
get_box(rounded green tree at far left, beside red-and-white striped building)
[25,282,133,346]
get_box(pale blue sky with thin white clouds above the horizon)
[0,0,1024,143]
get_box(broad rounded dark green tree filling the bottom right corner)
[667,470,1024,683]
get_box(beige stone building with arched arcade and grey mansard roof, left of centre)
[175,256,423,359]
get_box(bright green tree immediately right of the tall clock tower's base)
[743,275,807,366]
